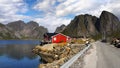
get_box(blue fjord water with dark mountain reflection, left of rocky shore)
[0,40,41,68]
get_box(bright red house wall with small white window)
[52,34,67,43]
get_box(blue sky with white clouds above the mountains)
[0,0,120,32]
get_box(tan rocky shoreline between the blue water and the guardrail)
[33,43,86,68]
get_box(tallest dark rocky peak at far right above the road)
[100,11,120,36]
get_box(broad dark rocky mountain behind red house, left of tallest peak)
[62,14,98,37]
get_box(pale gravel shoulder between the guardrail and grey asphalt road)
[70,43,97,68]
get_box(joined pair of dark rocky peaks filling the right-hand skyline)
[62,11,120,37]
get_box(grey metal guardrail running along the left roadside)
[60,44,91,68]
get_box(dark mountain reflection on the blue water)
[0,45,36,60]
